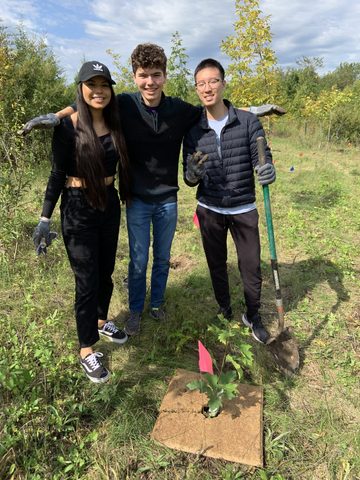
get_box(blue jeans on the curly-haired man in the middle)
[126,199,177,312]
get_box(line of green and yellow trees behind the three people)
[0,0,360,258]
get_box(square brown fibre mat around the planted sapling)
[151,369,263,467]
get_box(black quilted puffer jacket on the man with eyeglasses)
[183,100,272,207]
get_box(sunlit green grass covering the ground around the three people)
[0,129,360,480]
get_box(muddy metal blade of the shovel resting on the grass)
[267,328,300,375]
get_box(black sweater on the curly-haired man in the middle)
[117,92,202,202]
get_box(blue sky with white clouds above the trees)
[0,0,360,82]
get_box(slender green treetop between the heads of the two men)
[165,32,193,100]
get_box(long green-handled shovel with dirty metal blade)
[256,137,300,375]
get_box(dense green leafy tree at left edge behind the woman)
[0,27,74,258]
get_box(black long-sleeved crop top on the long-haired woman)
[41,117,119,218]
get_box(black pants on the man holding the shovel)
[196,206,262,317]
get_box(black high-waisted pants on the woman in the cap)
[60,185,120,348]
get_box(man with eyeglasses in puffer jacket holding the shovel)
[183,58,275,343]
